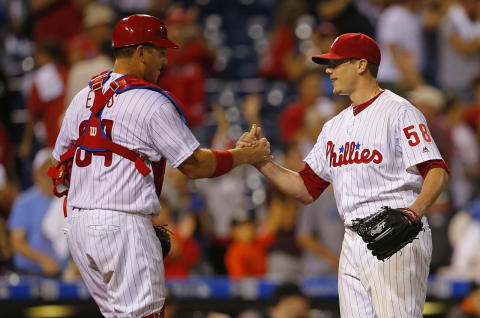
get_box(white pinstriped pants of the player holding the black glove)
[338,222,432,318]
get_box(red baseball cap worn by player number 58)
[312,33,381,66]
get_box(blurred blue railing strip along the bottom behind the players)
[0,276,472,301]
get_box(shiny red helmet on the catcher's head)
[112,14,178,49]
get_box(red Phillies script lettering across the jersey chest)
[327,141,383,167]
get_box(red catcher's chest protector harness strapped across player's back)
[48,71,187,197]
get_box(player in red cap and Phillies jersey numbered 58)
[237,33,448,318]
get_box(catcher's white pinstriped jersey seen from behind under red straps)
[53,73,199,214]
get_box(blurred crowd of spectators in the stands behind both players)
[0,0,480,317]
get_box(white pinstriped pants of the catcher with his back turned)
[67,209,166,318]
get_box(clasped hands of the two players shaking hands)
[235,124,273,168]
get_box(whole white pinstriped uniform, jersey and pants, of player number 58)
[305,91,441,318]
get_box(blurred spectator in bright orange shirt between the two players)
[225,215,273,279]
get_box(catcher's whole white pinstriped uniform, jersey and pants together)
[53,74,199,318]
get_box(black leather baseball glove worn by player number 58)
[353,206,423,261]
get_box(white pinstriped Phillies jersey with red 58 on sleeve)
[305,90,442,226]
